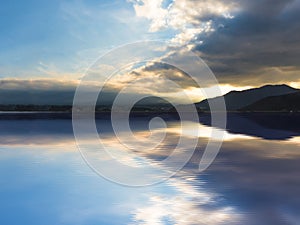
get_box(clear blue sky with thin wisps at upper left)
[0,0,172,78]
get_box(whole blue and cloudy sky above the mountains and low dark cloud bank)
[0,0,300,101]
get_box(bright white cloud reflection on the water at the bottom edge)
[130,178,239,225]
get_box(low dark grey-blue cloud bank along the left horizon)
[0,79,116,105]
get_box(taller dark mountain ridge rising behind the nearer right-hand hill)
[196,84,299,111]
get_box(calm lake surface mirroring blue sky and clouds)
[0,114,300,225]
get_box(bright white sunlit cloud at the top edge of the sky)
[130,0,238,44]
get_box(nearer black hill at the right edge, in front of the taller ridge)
[241,91,300,112]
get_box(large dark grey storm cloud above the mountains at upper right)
[195,0,300,85]
